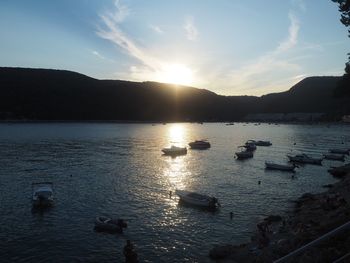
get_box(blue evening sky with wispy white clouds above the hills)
[0,0,350,96]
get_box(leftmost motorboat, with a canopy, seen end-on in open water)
[32,182,53,207]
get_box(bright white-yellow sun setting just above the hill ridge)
[159,64,193,86]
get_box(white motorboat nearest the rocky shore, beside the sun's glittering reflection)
[175,190,220,208]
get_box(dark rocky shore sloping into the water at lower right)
[209,173,350,263]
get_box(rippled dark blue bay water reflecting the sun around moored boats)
[0,123,350,262]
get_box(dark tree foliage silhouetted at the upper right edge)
[332,0,350,96]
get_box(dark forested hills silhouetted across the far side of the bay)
[0,67,349,121]
